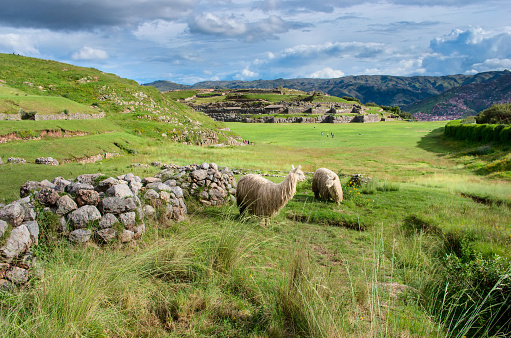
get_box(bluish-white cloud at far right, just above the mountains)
[423,27,511,74]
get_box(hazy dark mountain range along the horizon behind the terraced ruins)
[144,70,511,119]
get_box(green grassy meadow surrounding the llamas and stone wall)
[0,122,511,337]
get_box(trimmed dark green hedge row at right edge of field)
[444,120,511,144]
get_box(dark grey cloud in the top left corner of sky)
[0,0,199,30]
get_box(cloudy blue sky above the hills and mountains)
[0,0,511,84]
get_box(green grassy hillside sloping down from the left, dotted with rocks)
[0,54,240,166]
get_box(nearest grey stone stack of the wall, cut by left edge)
[0,198,41,290]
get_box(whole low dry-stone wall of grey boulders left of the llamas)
[0,163,236,290]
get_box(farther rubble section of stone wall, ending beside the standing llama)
[155,162,236,205]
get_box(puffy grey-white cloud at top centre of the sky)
[188,13,308,42]
